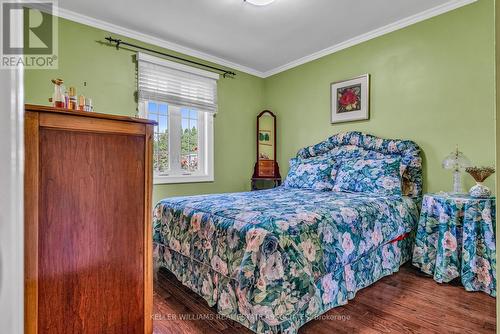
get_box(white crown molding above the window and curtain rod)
[56,7,263,78]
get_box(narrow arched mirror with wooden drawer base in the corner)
[252,110,281,190]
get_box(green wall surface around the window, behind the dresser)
[25,19,263,203]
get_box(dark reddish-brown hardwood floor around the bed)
[154,264,496,334]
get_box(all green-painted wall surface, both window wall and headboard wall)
[25,0,495,201]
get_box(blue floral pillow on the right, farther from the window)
[333,158,401,196]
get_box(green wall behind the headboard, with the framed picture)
[264,0,495,191]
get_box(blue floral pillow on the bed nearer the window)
[284,156,336,191]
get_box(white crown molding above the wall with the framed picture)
[263,0,477,78]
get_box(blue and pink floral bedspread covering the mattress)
[154,187,418,332]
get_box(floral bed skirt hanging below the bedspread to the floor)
[154,237,414,334]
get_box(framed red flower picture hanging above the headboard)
[331,74,370,123]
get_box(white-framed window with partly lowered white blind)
[138,53,218,184]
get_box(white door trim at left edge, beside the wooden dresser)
[0,31,24,334]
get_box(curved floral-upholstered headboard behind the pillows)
[297,131,422,197]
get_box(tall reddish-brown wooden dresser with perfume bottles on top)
[24,105,154,334]
